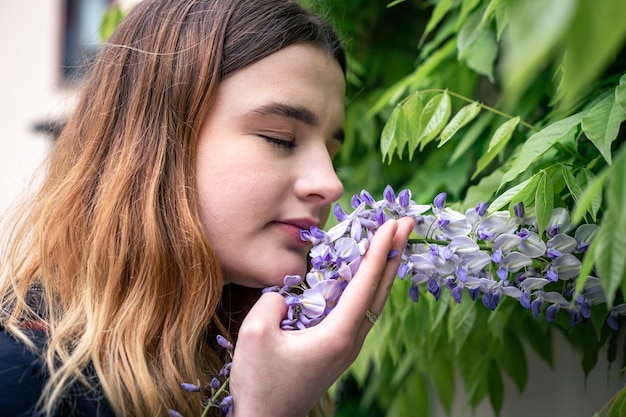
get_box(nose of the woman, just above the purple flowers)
[295,147,343,206]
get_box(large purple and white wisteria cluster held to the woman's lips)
[266,186,626,330]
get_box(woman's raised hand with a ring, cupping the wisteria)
[230,218,414,417]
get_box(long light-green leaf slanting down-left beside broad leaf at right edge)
[501,113,584,186]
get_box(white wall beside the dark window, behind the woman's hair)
[0,0,71,219]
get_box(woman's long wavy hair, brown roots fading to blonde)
[0,0,345,416]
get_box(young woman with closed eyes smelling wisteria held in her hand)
[0,0,413,417]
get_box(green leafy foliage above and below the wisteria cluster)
[316,0,626,416]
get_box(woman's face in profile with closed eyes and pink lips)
[196,44,345,287]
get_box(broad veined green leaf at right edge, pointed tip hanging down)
[582,94,626,165]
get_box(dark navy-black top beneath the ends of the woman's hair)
[0,327,114,417]
